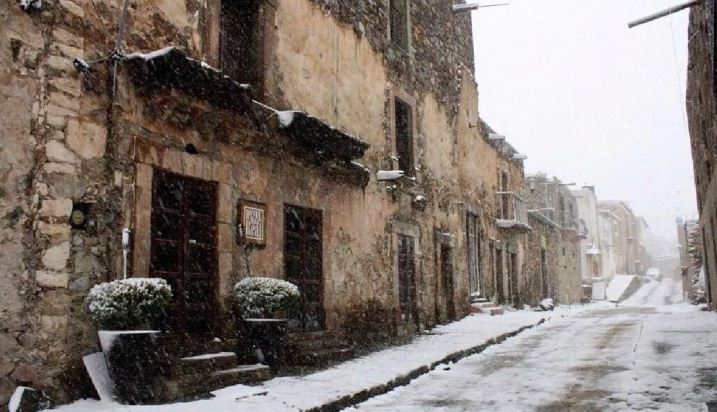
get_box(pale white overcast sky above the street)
[473,0,697,239]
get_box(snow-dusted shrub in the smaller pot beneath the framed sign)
[234,278,301,318]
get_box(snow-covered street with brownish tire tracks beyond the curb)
[356,280,717,411]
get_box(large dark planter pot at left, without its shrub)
[97,330,162,405]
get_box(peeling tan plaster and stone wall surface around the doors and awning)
[0,0,525,405]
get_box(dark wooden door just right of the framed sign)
[284,205,326,331]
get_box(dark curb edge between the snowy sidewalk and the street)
[305,319,545,412]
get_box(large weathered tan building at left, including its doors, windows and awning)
[0,0,528,405]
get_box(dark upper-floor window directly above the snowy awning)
[219,0,262,87]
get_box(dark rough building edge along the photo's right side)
[687,0,717,309]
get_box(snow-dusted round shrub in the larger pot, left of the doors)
[86,278,172,330]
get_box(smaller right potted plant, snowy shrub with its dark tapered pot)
[234,277,301,370]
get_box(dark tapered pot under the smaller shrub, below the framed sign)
[242,319,288,372]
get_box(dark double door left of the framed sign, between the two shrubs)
[150,170,217,334]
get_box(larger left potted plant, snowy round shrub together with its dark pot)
[86,278,172,404]
